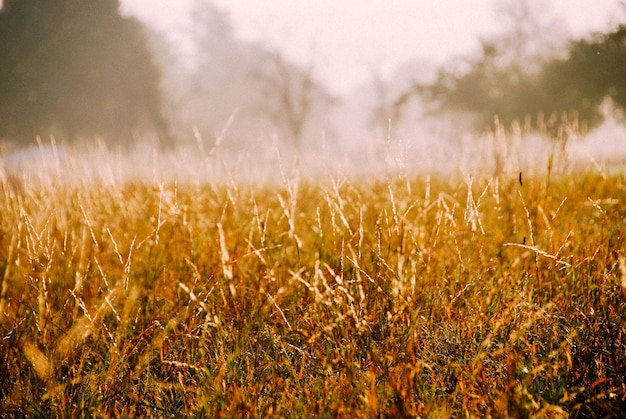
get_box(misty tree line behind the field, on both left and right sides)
[0,0,626,149]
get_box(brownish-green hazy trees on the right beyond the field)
[395,2,626,135]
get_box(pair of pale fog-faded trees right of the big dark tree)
[151,0,330,158]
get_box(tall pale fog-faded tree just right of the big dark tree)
[176,0,264,148]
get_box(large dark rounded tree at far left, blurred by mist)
[0,0,170,146]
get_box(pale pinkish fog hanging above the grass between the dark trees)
[0,0,626,182]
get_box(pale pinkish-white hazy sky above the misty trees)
[122,0,624,92]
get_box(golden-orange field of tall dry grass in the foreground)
[0,134,626,418]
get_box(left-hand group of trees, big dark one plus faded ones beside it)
[0,0,330,148]
